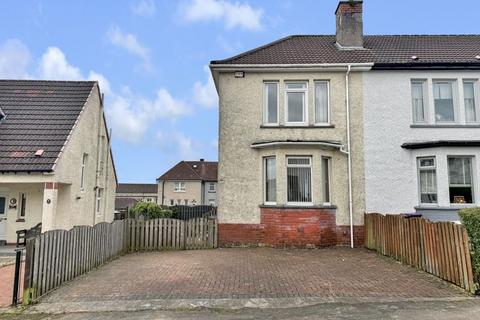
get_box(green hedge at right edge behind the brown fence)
[459,208,480,288]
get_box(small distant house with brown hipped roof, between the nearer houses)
[157,159,218,206]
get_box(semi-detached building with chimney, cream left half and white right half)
[210,0,480,246]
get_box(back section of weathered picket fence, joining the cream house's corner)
[126,218,217,251]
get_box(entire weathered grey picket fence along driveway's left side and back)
[23,218,218,304]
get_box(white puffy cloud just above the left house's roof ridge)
[38,47,83,80]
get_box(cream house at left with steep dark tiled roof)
[0,80,117,243]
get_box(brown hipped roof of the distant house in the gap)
[158,161,218,181]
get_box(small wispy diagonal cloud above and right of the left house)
[107,26,153,71]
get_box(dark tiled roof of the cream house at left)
[0,80,96,172]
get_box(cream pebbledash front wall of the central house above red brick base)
[217,71,365,225]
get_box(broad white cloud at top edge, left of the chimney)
[180,0,264,30]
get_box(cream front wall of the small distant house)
[158,180,202,206]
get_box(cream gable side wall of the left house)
[55,87,117,229]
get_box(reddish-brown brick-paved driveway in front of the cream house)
[43,248,465,302]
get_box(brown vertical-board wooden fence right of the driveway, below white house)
[365,213,475,293]
